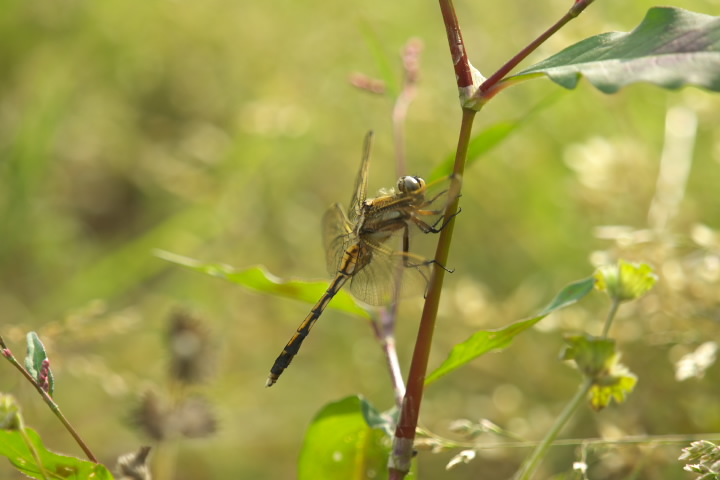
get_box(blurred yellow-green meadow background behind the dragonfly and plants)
[0,0,720,479]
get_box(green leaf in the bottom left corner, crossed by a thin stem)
[0,428,113,480]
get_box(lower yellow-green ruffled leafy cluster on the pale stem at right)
[561,335,637,411]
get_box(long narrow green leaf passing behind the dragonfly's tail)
[155,250,370,319]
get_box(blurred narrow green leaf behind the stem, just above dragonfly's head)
[428,91,565,181]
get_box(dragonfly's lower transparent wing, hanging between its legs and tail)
[350,242,431,305]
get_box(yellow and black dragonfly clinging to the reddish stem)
[265,131,460,387]
